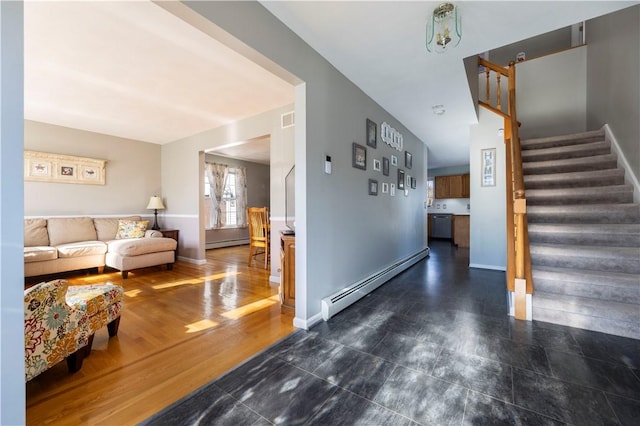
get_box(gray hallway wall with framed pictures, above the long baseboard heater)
[182,2,426,325]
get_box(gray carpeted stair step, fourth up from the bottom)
[529,223,640,247]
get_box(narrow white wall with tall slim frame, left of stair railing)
[469,108,507,270]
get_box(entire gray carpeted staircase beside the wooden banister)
[522,130,640,339]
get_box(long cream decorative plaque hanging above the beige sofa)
[24,151,106,185]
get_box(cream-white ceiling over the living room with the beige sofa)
[24,1,294,148]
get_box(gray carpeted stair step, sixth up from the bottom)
[526,185,633,205]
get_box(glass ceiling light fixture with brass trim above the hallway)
[426,3,462,53]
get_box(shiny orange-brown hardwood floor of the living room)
[26,246,294,425]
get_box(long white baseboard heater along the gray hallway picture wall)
[322,247,429,321]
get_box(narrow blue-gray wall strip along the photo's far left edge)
[0,1,25,425]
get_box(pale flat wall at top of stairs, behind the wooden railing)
[516,46,587,139]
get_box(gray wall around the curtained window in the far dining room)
[205,154,270,244]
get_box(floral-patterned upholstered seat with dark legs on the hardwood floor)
[24,280,124,381]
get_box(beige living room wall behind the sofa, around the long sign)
[24,120,161,218]
